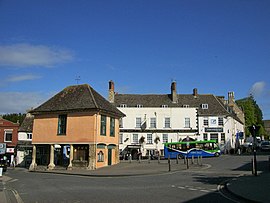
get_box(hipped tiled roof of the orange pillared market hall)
[31,84,124,117]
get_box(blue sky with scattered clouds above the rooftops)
[0,0,270,119]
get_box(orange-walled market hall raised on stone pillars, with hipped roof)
[30,84,124,170]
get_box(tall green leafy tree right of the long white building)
[236,95,265,135]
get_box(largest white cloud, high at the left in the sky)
[0,44,73,67]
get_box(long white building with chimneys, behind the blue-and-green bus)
[109,81,244,158]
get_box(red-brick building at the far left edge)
[0,117,20,165]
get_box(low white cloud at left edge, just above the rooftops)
[0,92,51,114]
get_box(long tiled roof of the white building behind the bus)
[115,94,229,116]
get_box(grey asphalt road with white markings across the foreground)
[3,155,267,203]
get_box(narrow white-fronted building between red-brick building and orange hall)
[16,113,34,167]
